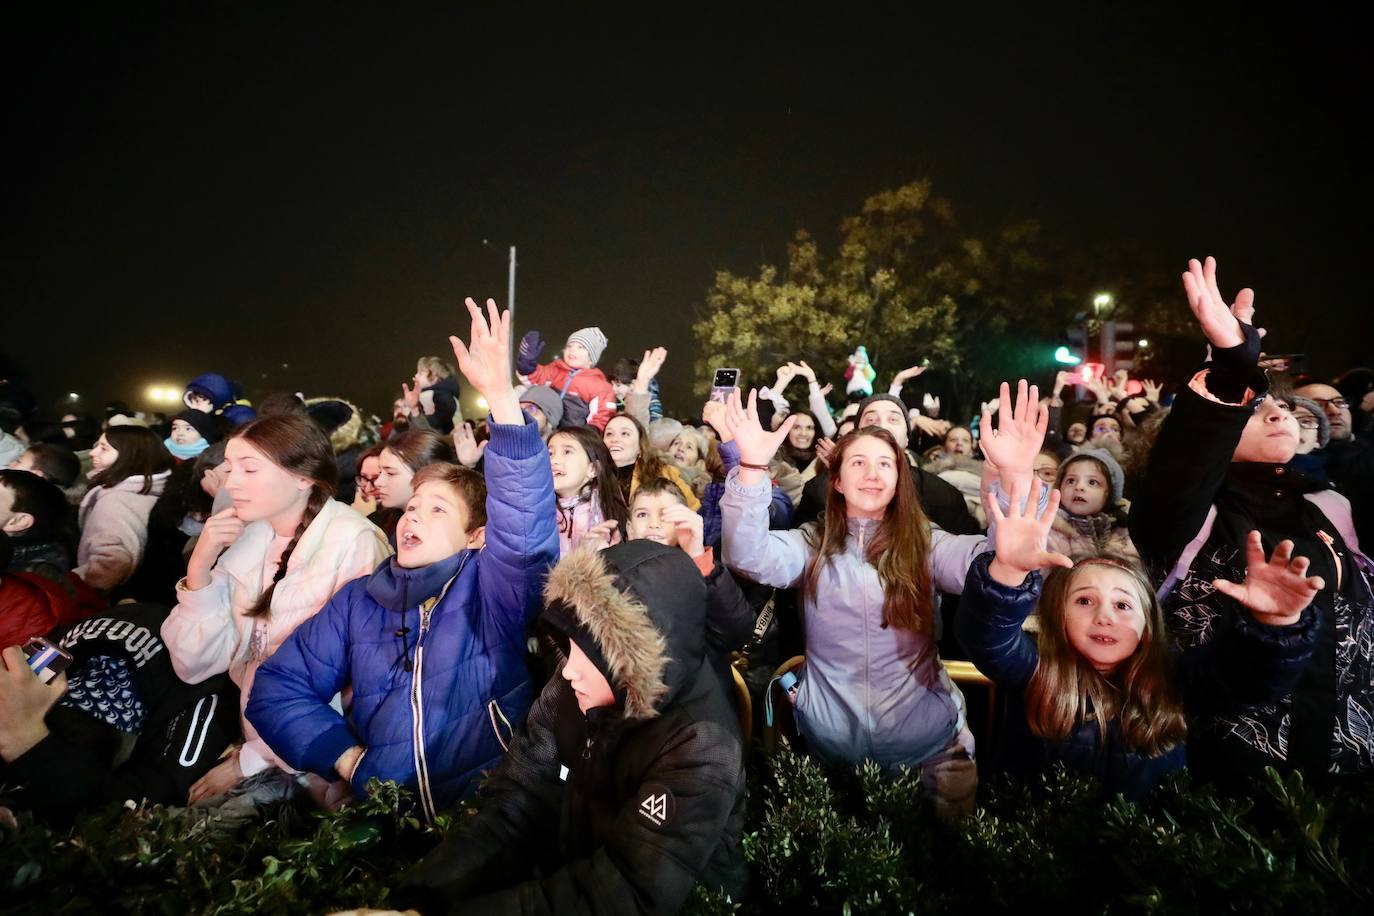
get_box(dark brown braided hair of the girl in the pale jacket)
[229,415,338,617]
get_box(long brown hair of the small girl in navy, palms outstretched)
[1026,555,1187,757]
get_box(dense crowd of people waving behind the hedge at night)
[0,258,1374,912]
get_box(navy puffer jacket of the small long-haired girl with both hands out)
[955,553,1316,801]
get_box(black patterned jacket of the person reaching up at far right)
[1131,343,1374,781]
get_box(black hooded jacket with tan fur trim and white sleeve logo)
[398,541,745,915]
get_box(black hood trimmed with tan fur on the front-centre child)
[544,541,706,720]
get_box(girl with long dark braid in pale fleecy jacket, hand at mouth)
[162,416,390,805]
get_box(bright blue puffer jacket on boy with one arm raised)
[246,417,558,816]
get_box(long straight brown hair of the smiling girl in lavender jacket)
[802,426,934,633]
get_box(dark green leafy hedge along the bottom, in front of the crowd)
[0,748,1374,915]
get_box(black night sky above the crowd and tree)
[0,3,1374,420]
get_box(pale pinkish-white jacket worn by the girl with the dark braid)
[162,500,392,776]
